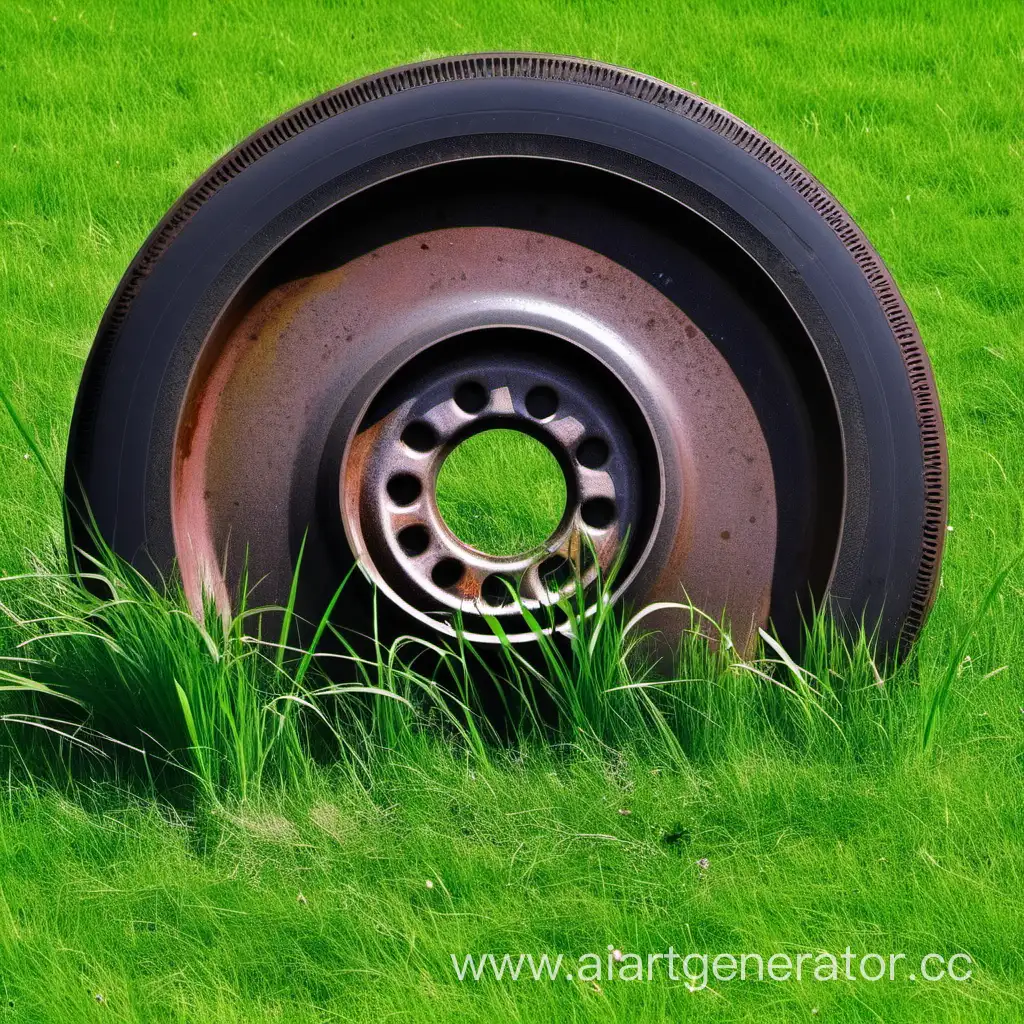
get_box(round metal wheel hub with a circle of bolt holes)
[348,348,640,616]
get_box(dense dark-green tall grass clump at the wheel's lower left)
[0,559,302,796]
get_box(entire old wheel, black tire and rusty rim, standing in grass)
[66,53,947,649]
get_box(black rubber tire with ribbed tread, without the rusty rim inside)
[66,54,946,647]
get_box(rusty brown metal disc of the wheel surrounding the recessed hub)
[172,227,776,647]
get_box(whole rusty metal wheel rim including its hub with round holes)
[172,227,776,644]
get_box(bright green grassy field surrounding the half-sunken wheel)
[0,0,1024,1022]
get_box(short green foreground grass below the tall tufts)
[0,745,1022,1024]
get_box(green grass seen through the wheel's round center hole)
[436,429,565,556]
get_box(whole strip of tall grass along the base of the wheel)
[0,551,929,800]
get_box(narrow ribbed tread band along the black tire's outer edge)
[66,52,947,649]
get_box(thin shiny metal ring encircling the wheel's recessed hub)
[338,319,666,643]
